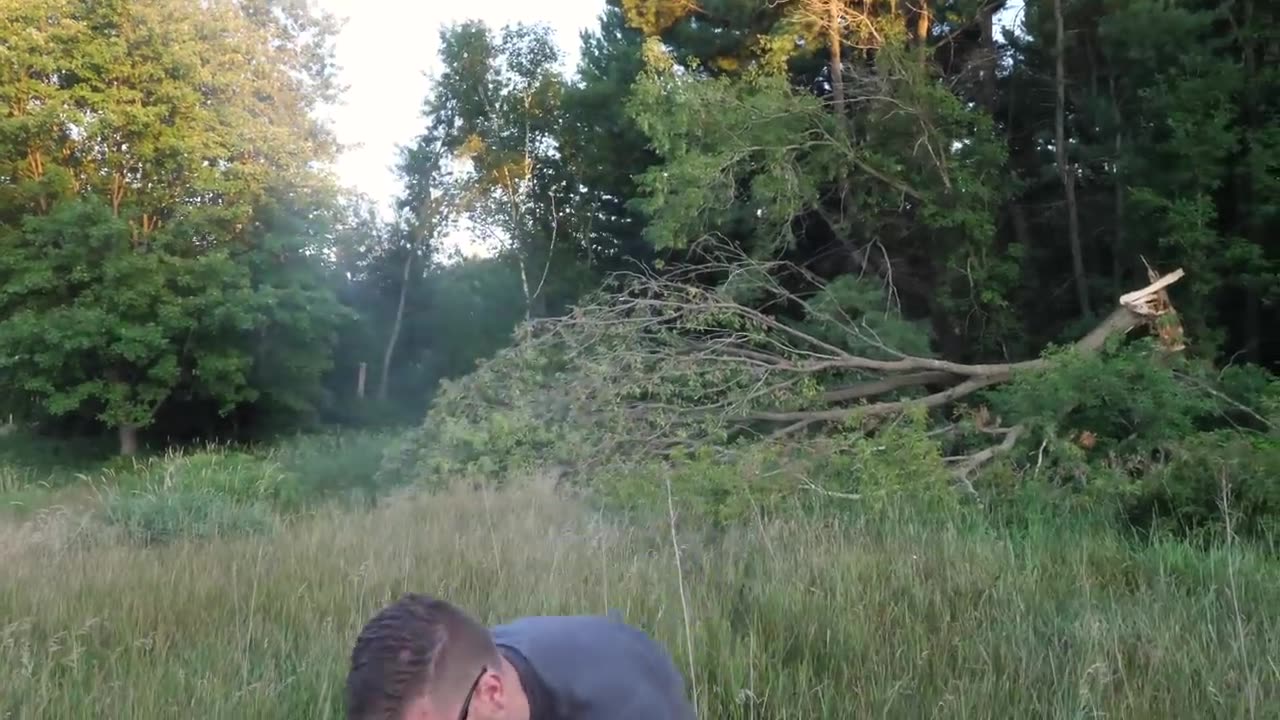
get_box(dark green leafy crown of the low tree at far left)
[0,201,261,428]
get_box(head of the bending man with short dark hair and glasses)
[347,593,529,720]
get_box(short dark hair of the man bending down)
[347,593,498,720]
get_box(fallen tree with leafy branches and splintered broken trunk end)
[384,235,1183,489]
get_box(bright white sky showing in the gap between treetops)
[314,0,604,252]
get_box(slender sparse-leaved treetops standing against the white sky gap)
[399,22,590,316]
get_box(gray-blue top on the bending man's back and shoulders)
[493,615,696,720]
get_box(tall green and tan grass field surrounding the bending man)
[0,486,1280,720]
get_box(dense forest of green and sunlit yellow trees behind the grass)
[0,0,1280,527]
